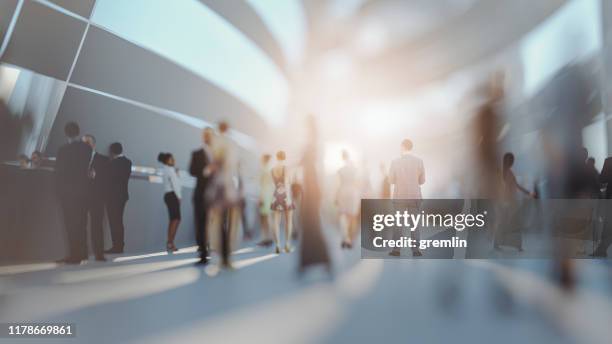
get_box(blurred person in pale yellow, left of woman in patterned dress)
[257,154,274,247]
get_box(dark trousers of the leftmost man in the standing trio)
[60,195,87,259]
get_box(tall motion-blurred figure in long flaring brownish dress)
[298,115,331,274]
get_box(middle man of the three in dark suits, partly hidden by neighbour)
[83,135,110,262]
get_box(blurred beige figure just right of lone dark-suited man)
[206,122,240,269]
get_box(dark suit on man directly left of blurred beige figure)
[189,148,211,261]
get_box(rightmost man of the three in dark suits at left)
[104,142,132,254]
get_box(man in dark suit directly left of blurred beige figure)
[189,128,214,264]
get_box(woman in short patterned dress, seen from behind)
[270,151,294,254]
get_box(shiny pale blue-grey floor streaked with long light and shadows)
[0,234,612,343]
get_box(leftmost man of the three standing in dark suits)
[55,122,92,264]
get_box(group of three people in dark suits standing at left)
[55,122,132,264]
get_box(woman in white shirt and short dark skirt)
[157,153,181,252]
